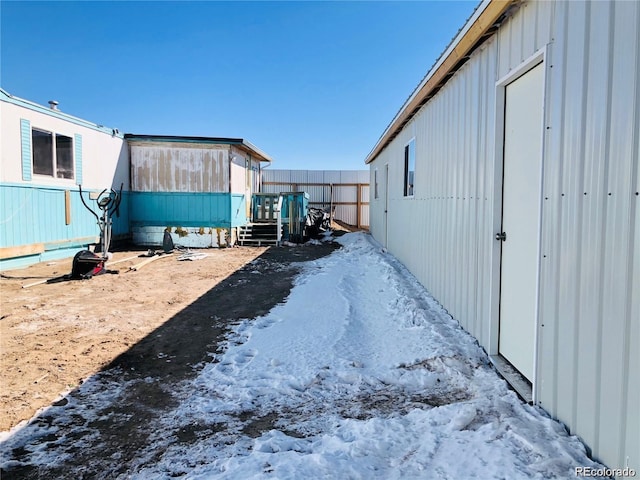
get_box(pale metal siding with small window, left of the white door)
[372,36,497,345]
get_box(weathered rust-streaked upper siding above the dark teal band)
[131,144,229,193]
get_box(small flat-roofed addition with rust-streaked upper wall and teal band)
[125,134,271,247]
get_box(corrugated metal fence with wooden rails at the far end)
[261,169,369,228]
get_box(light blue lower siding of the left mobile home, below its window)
[0,184,129,250]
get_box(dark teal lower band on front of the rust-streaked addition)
[129,192,239,227]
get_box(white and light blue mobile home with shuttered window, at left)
[0,89,129,269]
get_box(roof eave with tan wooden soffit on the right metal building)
[365,0,521,163]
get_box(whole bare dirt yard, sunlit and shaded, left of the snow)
[0,232,341,479]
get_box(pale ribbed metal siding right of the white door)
[540,2,640,468]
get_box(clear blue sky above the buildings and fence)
[0,0,478,169]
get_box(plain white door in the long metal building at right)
[499,64,544,381]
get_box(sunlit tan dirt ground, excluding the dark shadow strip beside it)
[0,248,266,430]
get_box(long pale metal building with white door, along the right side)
[366,1,640,471]
